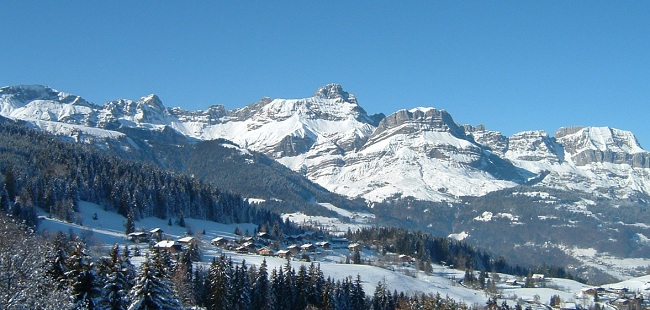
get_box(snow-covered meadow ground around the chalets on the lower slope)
[33,202,650,305]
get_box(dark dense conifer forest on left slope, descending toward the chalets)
[0,121,282,230]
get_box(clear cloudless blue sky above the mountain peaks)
[0,0,650,149]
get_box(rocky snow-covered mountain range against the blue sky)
[0,84,650,201]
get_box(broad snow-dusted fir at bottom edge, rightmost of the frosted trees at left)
[128,255,183,310]
